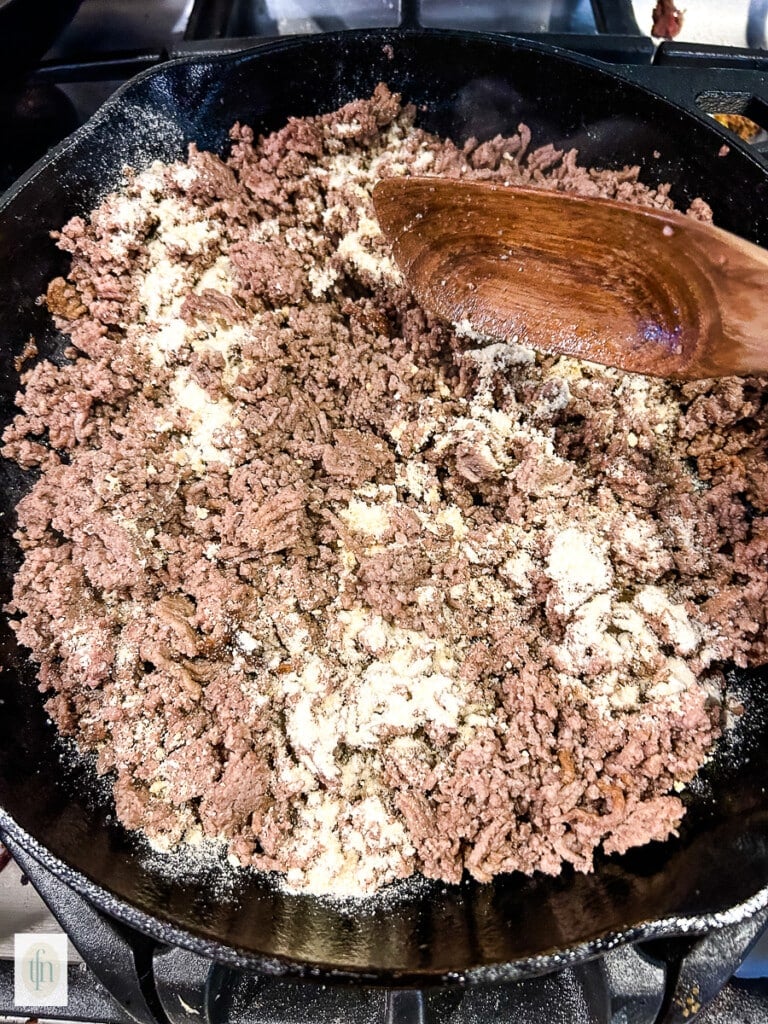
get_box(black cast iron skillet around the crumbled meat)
[0,32,768,984]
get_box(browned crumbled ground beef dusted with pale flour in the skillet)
[4,79,768,894]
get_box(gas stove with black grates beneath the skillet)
[0,0,768,1024]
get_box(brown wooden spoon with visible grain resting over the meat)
[374,177,768,380]
